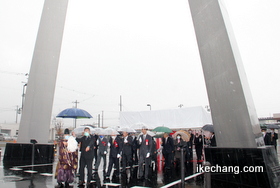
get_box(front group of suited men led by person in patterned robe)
[55,126,156,187]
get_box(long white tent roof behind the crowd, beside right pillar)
[120,106,212,129]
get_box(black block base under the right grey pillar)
[205,147,280,188]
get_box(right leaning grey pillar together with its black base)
[189,0,279,187]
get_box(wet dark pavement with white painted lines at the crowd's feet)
[0,142,203,188]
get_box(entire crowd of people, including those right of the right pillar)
[53,126,278,187]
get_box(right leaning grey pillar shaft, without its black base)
[189,0,263,148]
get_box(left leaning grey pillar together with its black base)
[3,0,68,165]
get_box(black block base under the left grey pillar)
[3,143,54,168]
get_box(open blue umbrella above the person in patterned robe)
[56,108,92,127]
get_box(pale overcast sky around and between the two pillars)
[0,0,280,127]
